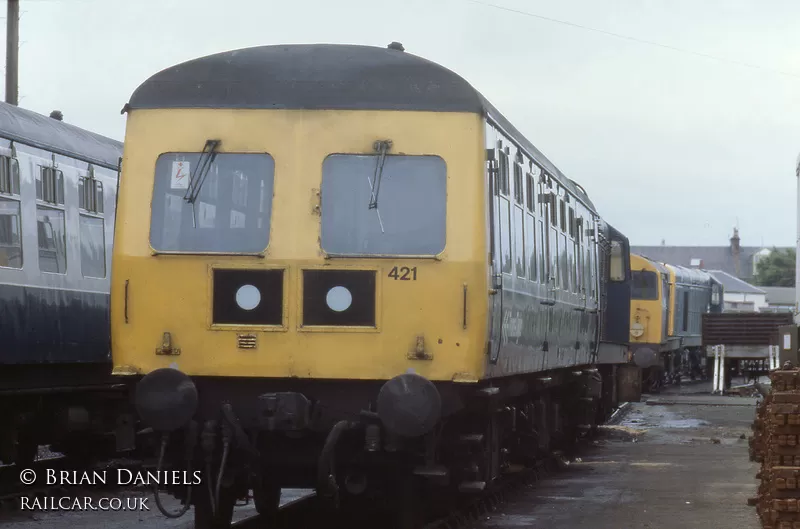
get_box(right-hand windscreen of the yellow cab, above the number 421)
[320,153,450,256]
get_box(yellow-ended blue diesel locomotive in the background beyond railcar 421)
[630,254,724,390]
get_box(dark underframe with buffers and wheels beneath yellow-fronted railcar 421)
[144,365,617,529]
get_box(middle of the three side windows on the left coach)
[36,166,67,274]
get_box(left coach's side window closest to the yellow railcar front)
[78,167,106,279]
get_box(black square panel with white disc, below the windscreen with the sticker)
[212,269,283,325]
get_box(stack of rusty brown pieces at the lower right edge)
[751,363,800,529]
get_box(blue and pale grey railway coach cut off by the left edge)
[0,103,134,465]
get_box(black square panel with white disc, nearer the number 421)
[303,270,376,327]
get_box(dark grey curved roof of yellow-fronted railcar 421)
[123,44,595,211]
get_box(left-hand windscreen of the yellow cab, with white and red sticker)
[150,152,276,254]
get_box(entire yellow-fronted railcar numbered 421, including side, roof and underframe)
[112,45,630,527]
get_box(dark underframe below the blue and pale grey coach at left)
[0,364,136,466]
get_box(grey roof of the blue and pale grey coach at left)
[0,102,122,169]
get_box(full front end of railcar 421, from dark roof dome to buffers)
[111,42,489,527]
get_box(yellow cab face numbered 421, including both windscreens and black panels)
[112,109,488,381]
